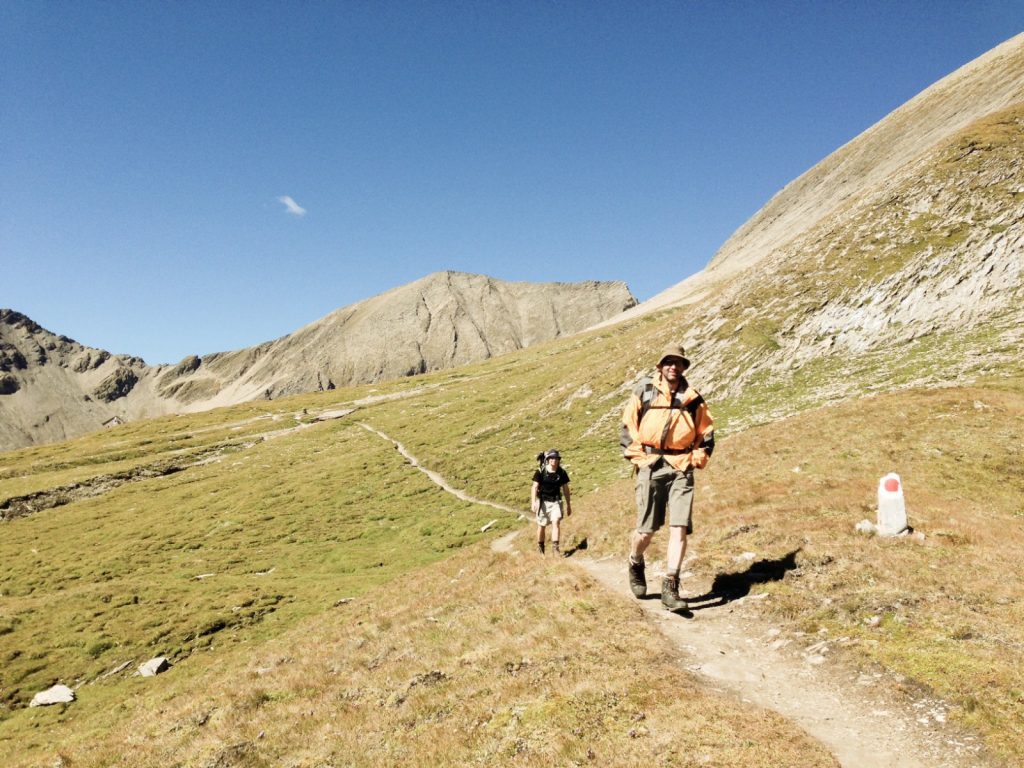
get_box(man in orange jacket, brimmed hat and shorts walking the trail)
[623,346,715,610]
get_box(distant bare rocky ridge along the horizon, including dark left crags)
[0,271,636,450]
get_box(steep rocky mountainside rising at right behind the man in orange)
[593,36,1024,430]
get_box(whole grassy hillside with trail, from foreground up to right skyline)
[0,28,1024,768]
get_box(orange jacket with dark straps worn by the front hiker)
[623,374,715,470]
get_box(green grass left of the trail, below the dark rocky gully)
[0,422,501,715]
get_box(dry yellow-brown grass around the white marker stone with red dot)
[578,383,1024,765]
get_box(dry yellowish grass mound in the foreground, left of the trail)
[41,546,836,767]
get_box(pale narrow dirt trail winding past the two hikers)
[361,424,980,768]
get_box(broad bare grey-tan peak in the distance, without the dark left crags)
[184,271,635,404]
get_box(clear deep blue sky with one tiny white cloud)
[0,0,1024,364]
